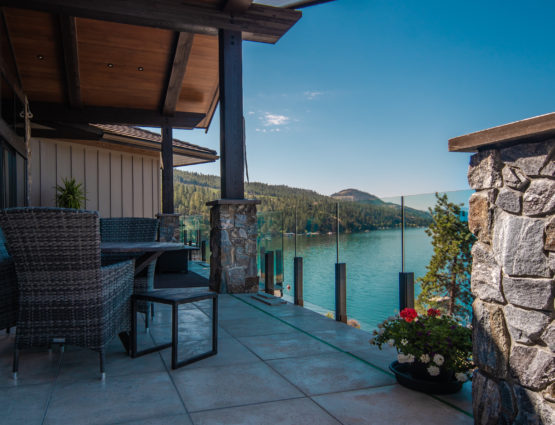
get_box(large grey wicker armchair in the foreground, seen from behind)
[0,208,134,378]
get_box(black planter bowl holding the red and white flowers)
[389,361,462,394]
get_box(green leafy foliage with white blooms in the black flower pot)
[370,312,472,373]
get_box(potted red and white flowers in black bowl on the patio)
[370,308,473,394]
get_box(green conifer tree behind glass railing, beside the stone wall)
[417,193,475,321]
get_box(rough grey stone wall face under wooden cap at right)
[468,139,555,424]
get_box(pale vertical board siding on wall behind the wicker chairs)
[30,139,160,217]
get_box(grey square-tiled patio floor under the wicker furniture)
[0,264,473,425]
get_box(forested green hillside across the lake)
[174,170,431,233]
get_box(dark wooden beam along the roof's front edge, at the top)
[0,0,302,43]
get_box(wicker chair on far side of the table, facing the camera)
[100,217,158,329]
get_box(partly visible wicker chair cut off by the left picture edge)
[0,229,19,333]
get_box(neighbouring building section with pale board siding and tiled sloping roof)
[28,124,218,217]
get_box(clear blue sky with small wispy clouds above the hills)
[175,0,555,196]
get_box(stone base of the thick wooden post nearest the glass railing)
[207,199,260,294]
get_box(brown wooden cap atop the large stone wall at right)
[449,112,555,152]
